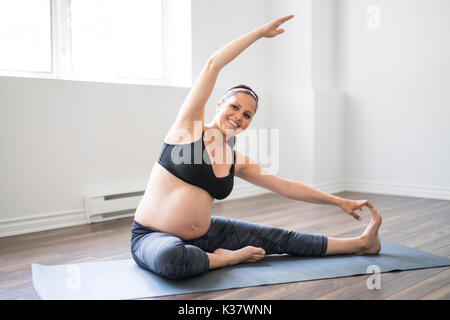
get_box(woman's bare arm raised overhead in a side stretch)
[171,15,293,126]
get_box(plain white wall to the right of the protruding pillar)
[335,0,450,199]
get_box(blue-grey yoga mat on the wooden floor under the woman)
[31,240,450,300]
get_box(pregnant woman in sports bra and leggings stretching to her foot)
[131,15,381,279]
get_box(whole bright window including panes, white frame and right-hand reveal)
[0,0,191,86]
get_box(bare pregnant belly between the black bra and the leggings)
[135,163,214,240]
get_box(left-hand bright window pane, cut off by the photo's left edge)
[0,0,52,72]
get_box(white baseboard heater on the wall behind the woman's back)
[84,191,144,223]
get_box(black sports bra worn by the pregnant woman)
[158,132,236,199]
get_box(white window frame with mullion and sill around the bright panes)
[0,0,169,86]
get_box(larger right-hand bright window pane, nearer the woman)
[69,0,163,79]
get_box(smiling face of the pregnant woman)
[214,92,256,135]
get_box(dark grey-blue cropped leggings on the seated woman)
[131,216,328,279]
